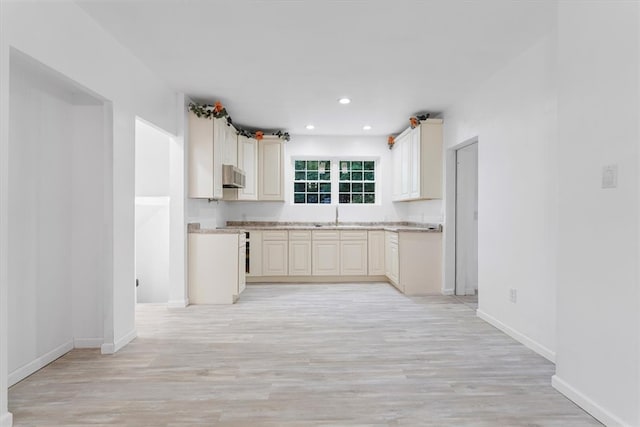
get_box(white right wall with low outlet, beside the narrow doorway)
[444,34,558,359]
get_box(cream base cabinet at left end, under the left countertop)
[188,233,246,304]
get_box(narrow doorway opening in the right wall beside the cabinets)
[455,142,478,295]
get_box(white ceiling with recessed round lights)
[78,0,556,135]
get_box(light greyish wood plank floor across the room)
[9,284,599,427]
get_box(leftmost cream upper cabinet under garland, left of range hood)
[188,112,227,199]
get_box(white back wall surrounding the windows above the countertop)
[218,135,442,225]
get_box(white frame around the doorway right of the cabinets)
[442,135,480,295]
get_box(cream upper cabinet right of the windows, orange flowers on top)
[392,119,443,201]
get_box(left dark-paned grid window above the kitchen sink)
[293,160,331,204]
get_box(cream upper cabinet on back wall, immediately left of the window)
[258,136,284,201]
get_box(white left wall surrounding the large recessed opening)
[0,1,179,423]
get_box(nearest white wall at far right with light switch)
[553,1,640,426]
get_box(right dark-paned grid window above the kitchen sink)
[338,160,376,204]
